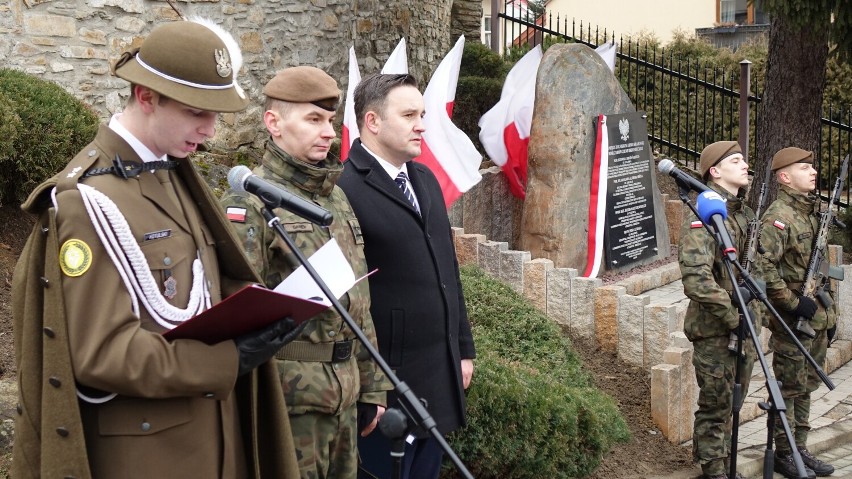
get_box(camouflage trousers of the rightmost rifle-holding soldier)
[769,330,828,455]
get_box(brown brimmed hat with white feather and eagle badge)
[112,19,248,112]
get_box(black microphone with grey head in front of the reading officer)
[228,165,334,226]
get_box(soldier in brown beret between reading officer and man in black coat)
[221,66,391,479]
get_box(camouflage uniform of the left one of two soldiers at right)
[678,181,759,476]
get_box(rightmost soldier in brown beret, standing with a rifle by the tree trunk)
[760,147,836,478]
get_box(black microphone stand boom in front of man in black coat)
[258,204,473,479]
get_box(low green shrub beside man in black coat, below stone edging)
[445,267,629,479]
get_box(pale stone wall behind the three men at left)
[0,0,462,149]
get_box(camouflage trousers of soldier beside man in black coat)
[290,404,358,479]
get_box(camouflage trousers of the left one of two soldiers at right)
[692,336,755,476]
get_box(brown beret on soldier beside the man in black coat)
[263,66,340,111]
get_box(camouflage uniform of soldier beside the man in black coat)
[221,140,392,479]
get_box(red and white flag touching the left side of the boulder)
[479,45,542,199]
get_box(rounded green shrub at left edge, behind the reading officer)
[0,69,99,207]
